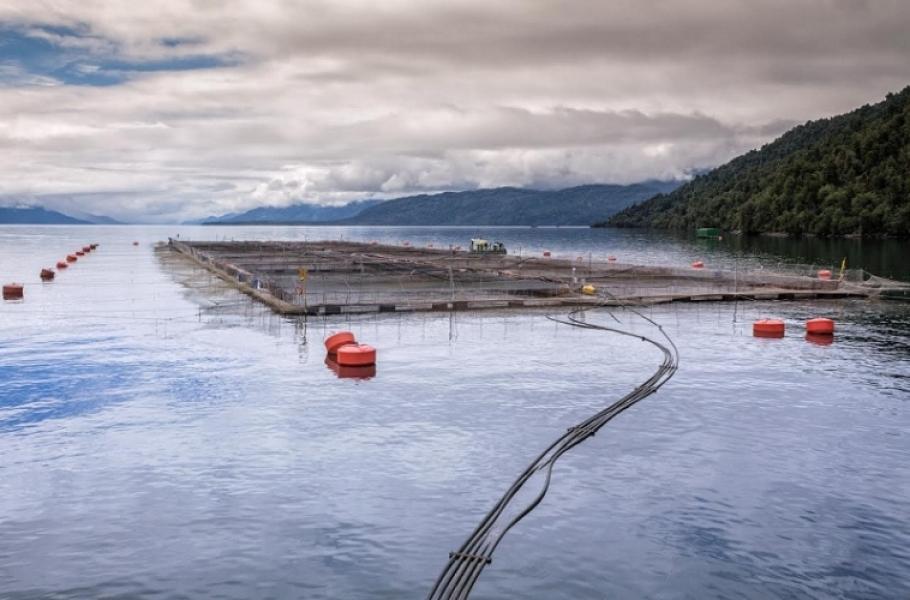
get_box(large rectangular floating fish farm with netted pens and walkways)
[168,239,902,315]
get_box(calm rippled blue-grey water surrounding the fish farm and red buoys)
[0,227,910,600]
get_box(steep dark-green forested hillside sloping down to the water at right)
[602,87,910,238]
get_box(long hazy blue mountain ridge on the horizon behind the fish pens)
[204,181,682,225]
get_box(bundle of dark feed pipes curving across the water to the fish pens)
[427,294,679,600]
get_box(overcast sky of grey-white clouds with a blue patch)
[0,0,910,221]
